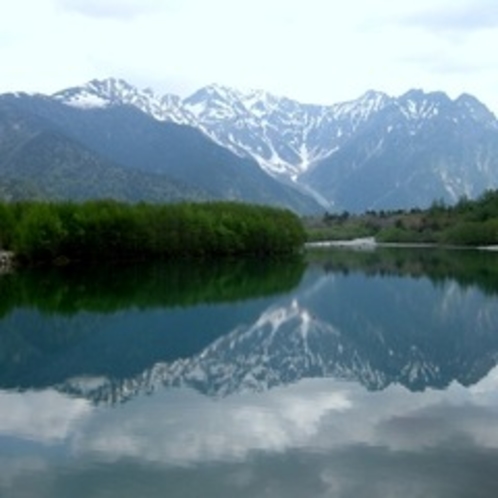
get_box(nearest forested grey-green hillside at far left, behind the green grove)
[0,99,209,202]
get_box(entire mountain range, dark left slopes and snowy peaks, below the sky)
[0,79,498,214]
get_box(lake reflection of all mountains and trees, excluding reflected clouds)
[0,251,498,396]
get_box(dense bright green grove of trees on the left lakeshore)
[0,201,305,263]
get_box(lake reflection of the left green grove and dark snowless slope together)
[0,260,304,389]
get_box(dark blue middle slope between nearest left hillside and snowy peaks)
[0,92,317,212]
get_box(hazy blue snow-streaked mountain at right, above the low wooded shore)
[300,90,498,211]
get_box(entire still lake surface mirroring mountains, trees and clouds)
[0,249,498,498]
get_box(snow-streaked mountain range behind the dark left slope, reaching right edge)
[54,79,498,211]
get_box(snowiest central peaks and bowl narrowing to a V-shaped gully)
[185,86,389,181]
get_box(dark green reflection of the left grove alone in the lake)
[0,258,304,317]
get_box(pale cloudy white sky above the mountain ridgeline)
[0,0,498,114]
